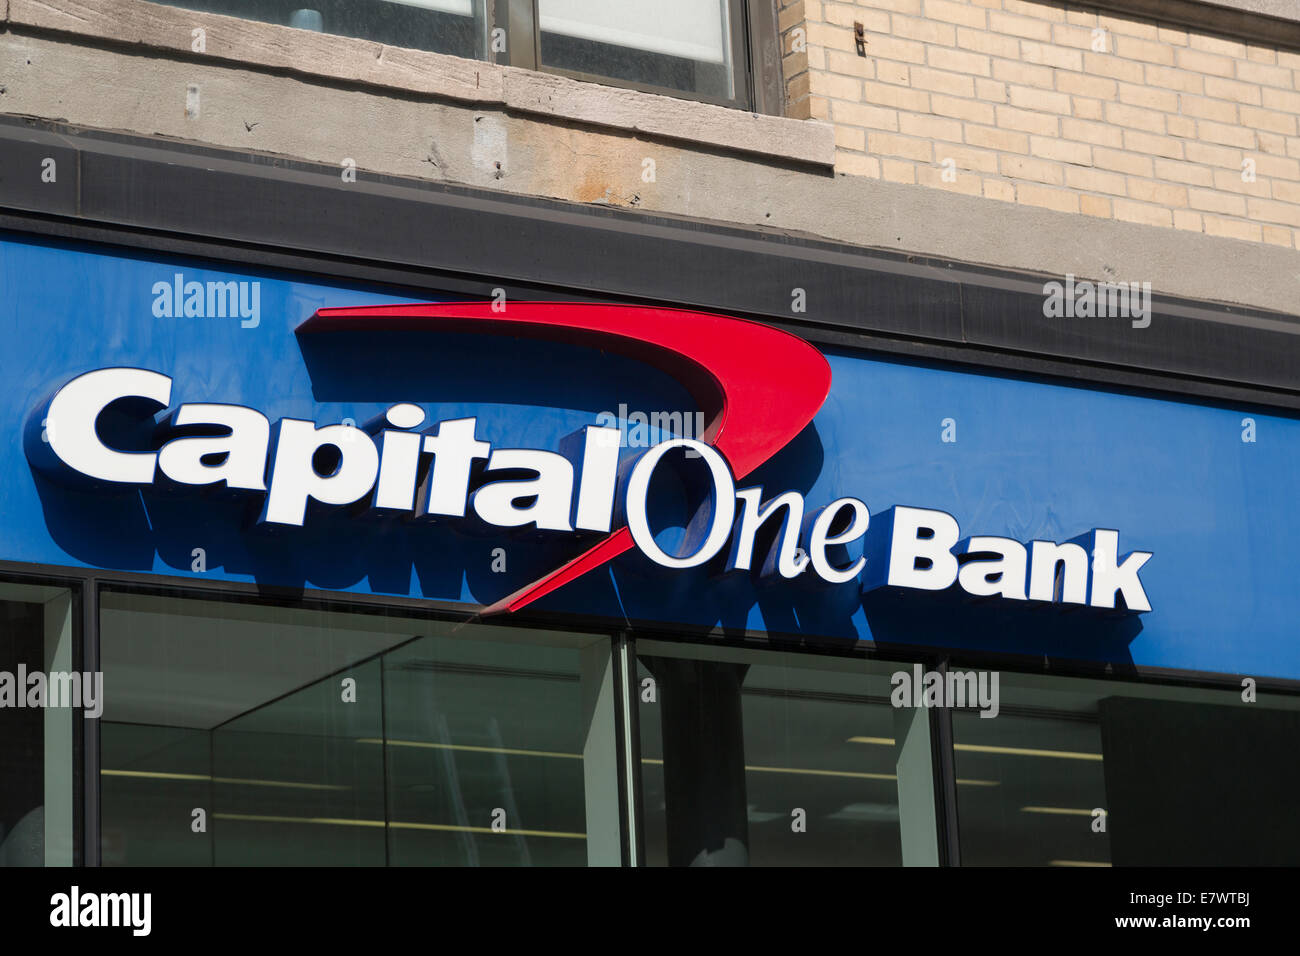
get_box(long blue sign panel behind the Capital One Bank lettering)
[0,237,1300,679]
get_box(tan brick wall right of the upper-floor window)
[777,0,1300,248]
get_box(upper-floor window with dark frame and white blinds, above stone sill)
[163,0,774,108]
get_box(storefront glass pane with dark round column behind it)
[638,641,935,866]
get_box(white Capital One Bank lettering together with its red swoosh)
[25,303,1152,613]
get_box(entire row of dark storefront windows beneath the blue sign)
[20,564,1300,866]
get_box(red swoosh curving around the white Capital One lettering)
[298,302,831,615]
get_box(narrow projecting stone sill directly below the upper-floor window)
[0,0,835,169]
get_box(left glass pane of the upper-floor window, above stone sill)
[161,0,486,59]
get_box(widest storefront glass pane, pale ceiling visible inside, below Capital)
[101,593,620,866]
